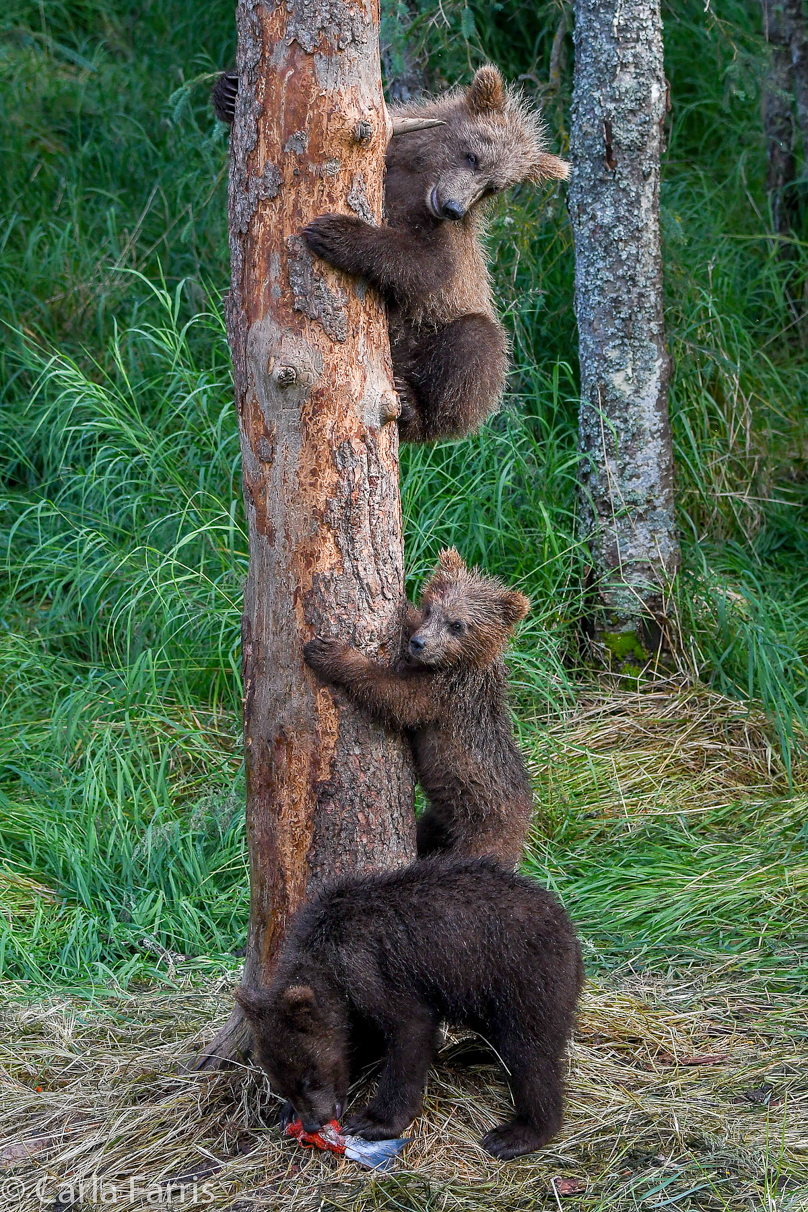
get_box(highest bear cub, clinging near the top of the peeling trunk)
[213,67,568,442]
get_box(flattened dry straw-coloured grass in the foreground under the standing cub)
[0,978,808,1212]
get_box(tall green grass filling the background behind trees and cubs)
[0,0,808,991]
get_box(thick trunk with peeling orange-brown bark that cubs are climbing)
[197,0,414,1068]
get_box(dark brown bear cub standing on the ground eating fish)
[236,856,584,1160]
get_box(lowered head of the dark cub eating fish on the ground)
[235,984,349,1132]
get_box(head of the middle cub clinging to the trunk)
[408,548,531,669]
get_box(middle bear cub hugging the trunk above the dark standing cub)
[304,549,533,865]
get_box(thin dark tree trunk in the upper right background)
[762,0,796,235]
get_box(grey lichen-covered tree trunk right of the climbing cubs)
[569,0,680,671]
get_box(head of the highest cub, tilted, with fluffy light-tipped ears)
[388,65,569,221]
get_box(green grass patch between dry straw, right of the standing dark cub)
[528,796,808,997]
